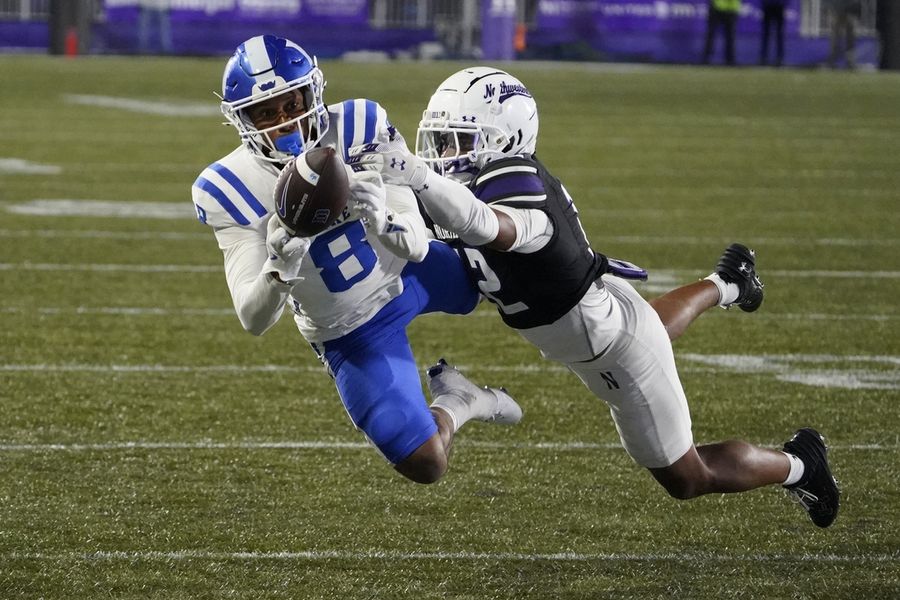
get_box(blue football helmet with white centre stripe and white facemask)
[221,35,328,164]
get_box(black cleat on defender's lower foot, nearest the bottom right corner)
[784,427,841,527]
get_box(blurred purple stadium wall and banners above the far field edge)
[0,0,900,69]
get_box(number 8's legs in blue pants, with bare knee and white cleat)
[323,243,521,483]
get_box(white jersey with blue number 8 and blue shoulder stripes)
[192,99,407,342]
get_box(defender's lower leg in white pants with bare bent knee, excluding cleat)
[569,279,790,498]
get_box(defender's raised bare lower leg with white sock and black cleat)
[650,244,763,340]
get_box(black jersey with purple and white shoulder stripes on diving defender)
[426,156,606,329]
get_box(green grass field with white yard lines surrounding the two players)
[0,56,900,600]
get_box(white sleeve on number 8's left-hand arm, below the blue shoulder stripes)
[215,220,291,335]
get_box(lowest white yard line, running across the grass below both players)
[0,549,900,564]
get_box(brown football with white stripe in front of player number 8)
[275,147,350,237]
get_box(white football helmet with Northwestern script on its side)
[416,67,538,183]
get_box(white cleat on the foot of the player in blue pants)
[427,358,522,425]
